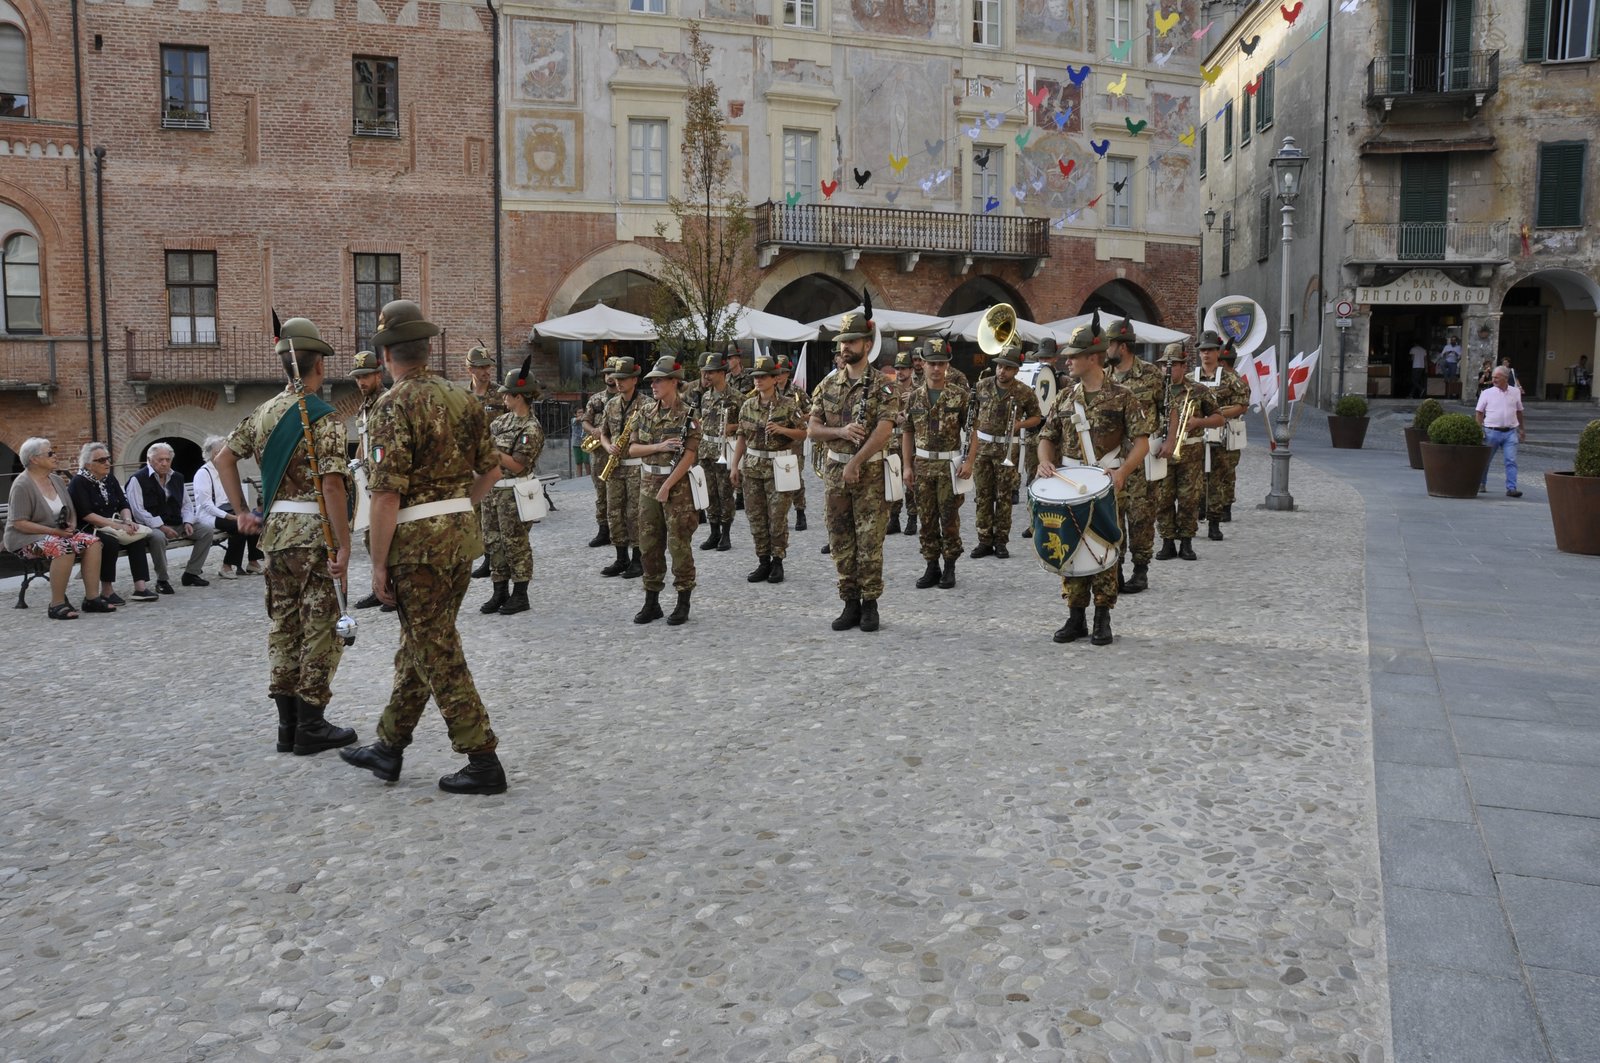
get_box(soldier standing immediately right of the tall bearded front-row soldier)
[894,351,970,591]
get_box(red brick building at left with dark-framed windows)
[0,0,494,480]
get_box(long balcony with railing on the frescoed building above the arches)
[755,202,1050,273]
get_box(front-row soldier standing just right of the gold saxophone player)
[629,354,701,624]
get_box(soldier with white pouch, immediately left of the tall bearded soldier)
[733,355,811,583]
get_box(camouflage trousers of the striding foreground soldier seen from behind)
[378,562,496,752]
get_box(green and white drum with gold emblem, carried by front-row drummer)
[1027,466,1122,576]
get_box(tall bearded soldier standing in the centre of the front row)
[808,311,896,631]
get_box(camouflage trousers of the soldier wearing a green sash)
[267,548,344,704]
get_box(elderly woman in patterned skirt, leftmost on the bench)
[5,437,106,620]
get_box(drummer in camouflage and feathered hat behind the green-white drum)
[1035,314,1155,645]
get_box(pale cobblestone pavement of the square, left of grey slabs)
[0,447,1389,1063]
